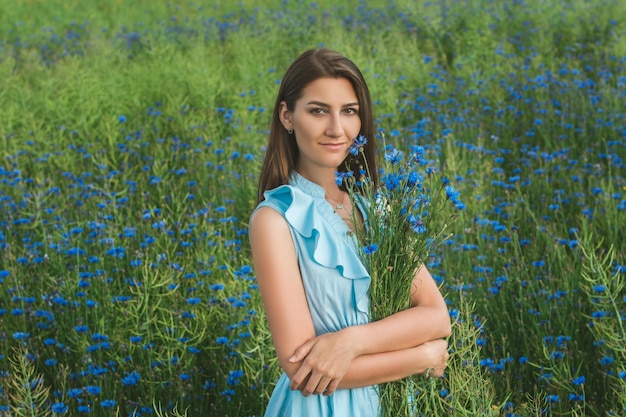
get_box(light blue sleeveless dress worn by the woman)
[258,172,381,417]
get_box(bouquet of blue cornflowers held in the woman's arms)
[337,136,465,417]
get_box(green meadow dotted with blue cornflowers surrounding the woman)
[0,0,626,417]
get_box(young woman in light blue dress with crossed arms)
[250,49,450,417]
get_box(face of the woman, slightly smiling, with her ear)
[280,78,361,175]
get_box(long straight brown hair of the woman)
[257,49,378,202]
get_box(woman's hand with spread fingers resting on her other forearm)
[289,329,357,397]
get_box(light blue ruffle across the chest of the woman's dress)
[261,173,371,315]
